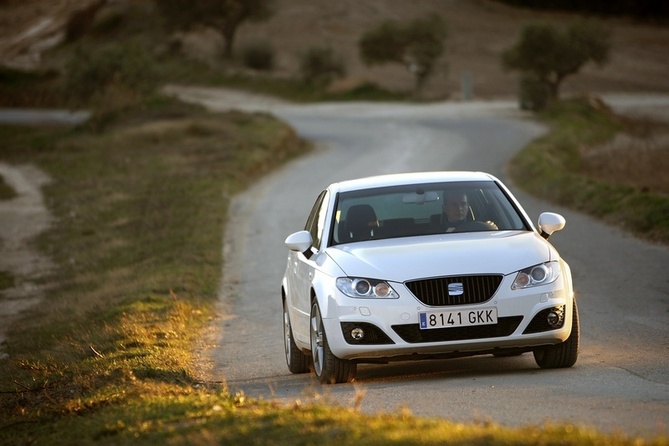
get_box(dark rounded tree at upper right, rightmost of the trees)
[502,21,611,109]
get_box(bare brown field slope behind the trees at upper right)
[239,0,669,98]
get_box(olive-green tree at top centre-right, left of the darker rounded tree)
[358,14,447,93]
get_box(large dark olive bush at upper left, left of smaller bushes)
[64,42,158,106]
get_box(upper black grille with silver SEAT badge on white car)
[406,275,502,307]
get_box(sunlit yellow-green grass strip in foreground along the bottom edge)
[11,390,666,446]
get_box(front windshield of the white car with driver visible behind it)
[330,181,529,245]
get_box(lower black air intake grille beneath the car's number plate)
[392,316,523,344]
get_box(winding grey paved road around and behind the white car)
[170,90,669,435]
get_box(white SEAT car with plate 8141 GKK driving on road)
[281,172,579,383]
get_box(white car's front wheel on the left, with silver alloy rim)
[310,301,357,384]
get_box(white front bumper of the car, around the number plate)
[323,280,573,362]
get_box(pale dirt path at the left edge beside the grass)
[0,163,52,359]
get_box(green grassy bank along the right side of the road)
[510,100,669,244]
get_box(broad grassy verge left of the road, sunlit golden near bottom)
[0,96,305,443]
